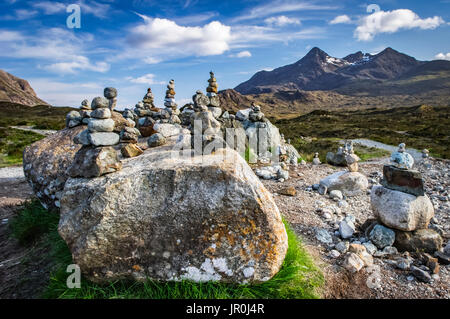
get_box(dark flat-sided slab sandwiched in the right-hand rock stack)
[381,165,425,196]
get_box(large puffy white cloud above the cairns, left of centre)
[128,15,231,56]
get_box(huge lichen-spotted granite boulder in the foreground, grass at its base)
[58,146,287,283]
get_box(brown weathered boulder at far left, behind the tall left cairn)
[23,125,86,209]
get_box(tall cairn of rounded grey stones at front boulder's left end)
[68,88,122,178]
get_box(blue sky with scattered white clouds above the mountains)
[0,0,450,108]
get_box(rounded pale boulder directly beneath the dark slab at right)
[370,185,434,231]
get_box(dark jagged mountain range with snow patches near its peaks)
[235,47,450,96]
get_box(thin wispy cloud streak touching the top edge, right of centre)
[233,0,336,22]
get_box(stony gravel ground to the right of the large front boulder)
[263,158,450,299]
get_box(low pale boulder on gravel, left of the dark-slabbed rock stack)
[319,171,369,197]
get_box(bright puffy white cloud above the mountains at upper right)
[354,9,445,41]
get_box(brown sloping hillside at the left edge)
[0,70,49,106]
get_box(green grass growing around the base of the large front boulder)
[11,201,324,299]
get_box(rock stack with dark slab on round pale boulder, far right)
[370,143,442,253]
